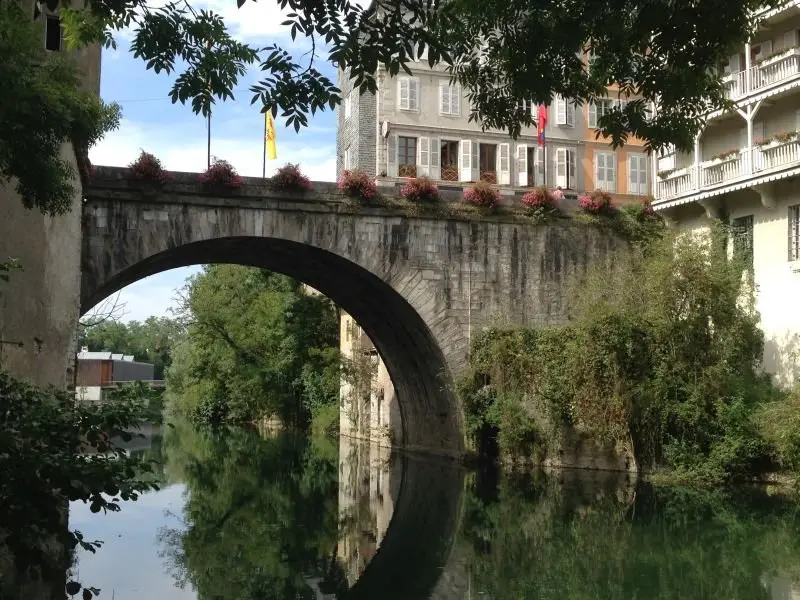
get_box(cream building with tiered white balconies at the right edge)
[653,0,800,385]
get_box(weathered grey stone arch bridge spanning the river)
[81,167,618,455]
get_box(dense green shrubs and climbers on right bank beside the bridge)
[460,226,800,483]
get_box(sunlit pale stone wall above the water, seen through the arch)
[339,312,401,443]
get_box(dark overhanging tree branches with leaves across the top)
[65,0,781,150]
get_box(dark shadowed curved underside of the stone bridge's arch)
[81,237,463,455]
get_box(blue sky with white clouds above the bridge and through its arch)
[89,0,344,321]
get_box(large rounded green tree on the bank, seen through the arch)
[166,265,339,427]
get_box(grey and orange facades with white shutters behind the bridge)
[336,48,650,202]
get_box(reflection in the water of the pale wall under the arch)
[337,436,402,586]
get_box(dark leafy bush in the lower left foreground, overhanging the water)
[0,372,157,598]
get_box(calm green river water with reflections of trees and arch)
[65,426,800,600]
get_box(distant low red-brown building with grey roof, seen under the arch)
[75,347,154,402]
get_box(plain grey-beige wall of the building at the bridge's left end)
[0,0,100,387]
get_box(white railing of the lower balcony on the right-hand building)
[656,138,800,201]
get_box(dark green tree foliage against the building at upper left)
[0,1,119,215]
